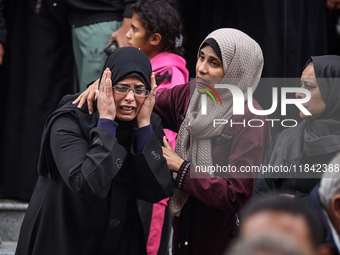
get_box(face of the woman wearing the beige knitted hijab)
[196,45,224,92]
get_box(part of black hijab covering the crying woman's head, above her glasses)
[99,47,152,90]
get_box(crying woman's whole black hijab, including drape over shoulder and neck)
[38,47,152,175]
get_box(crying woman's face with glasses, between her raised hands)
[112,76,147,121]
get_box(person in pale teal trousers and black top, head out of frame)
[66,0,136,91]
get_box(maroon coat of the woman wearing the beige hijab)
[155,83,271,255]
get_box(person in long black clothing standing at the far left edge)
[0,0,74,202]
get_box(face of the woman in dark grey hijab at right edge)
[295,64,326,120]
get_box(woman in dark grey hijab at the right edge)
[254,55,340,196]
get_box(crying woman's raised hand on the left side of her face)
[96,68,116,120]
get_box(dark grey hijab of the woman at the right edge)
[269,55,340,166]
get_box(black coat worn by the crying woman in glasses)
[16,93,173,255]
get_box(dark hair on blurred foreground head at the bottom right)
[241,195,326,247]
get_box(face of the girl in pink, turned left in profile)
[126,13,152,56]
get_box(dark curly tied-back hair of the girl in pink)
[133,0,184,56]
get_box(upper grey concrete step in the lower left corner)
[0,200,28,242]
